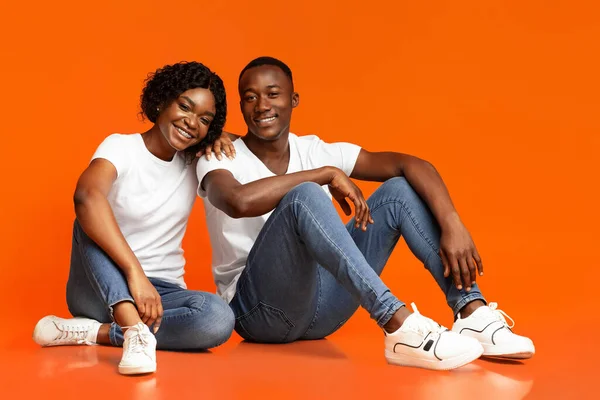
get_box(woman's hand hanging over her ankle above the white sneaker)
[127,270,163,333]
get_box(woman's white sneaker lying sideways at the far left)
[33,315,102,347]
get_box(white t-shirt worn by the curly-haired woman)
[92,133,198,288]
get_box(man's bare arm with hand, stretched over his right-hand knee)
[350,150,483,290]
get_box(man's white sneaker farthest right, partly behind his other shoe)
[452,303,535,359]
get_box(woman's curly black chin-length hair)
[140,61,227,163]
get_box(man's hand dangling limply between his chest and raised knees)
[329,168,373,231]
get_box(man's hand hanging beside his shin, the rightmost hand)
[440,217,483,292]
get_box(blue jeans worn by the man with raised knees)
[230,178,485,343]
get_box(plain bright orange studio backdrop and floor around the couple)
[0,0,600,400]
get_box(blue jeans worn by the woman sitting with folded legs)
[67,221,235,350]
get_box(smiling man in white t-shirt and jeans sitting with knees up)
[197,57,535,369]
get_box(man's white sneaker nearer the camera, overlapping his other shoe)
[384,303,483,370]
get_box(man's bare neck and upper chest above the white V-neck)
[242,132,290,175]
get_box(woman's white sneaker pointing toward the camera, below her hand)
[119,322,156,375]
